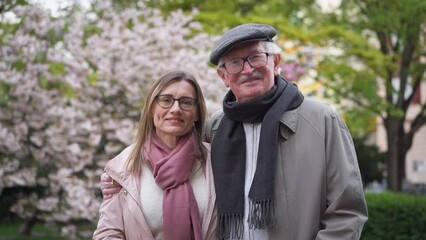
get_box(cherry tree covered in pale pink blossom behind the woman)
[0,1,225,237]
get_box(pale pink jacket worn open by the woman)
[93,144,216,240]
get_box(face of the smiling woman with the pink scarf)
[152,81,198,148]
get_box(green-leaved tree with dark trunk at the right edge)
[319,0,426,191]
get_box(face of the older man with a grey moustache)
[217,42,280,102]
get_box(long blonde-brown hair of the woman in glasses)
[126,70,207,176]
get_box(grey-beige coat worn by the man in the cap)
[206,99,368,240]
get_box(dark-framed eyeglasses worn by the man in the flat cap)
[220,52,271,74]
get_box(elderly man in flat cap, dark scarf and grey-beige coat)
[206,24,368,240]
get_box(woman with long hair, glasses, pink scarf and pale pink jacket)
[93,71,216,240]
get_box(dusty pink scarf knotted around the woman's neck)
[146,134,202,240]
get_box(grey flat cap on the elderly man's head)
[210,23,277,65]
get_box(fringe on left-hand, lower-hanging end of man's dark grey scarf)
[216,214,244,239]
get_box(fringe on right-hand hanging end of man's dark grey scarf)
[248,199,275,229]
